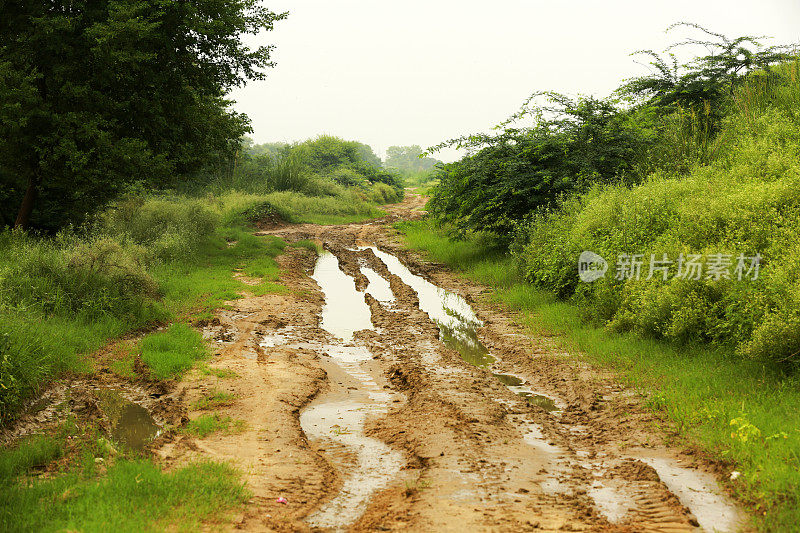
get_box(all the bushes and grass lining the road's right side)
[418,24,800,530]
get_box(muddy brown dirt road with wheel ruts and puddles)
[157,194,742,532]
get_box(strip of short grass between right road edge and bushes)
[397,221,800,531]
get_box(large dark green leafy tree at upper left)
[0,0,286,228]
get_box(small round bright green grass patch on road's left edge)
[139,322,208,379]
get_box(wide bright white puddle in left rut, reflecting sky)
[311,251,373,341]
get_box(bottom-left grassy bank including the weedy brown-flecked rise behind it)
[0,421,248,532]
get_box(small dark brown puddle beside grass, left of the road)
[95,389,160,451]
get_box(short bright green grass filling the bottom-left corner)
[0,458,248,532]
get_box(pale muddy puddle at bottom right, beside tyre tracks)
[637,455,742,532]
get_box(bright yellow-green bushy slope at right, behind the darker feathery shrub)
[514,64,800,365]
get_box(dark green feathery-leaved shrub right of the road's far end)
[429,93,651,240]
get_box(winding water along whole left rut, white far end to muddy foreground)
[300,248,404,531]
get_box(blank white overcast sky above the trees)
[231,0,800,161]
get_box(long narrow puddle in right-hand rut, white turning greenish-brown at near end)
[370,246,494,367]
